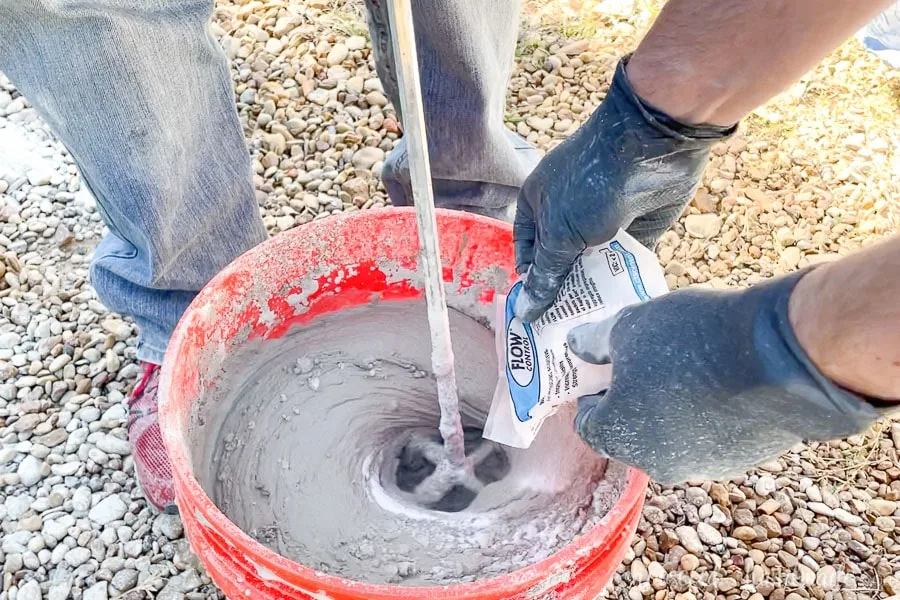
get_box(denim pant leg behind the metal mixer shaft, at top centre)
[366,0,540,219]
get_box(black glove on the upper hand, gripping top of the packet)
[513,58,734,321]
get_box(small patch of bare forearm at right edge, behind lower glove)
[790,235,900,400]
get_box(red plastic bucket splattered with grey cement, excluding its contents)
[160,208,647,600]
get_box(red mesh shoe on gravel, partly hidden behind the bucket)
[128,363,178,514]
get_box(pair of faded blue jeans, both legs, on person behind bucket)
[0,0,537,363]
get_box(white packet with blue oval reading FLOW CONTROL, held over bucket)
[484,230,669,448]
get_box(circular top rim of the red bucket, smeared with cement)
[159,207,649,600]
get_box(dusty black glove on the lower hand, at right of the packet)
[568,272,881,483]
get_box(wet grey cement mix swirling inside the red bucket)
[191,301,625,585]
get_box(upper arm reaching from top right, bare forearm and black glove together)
[514,0,891,321]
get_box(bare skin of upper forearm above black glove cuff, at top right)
[628,0,892,125]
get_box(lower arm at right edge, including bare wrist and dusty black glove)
[569,236,900,483]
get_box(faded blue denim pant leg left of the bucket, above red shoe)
[0,0,266,363]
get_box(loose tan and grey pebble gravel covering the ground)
[0,0,900,600]
